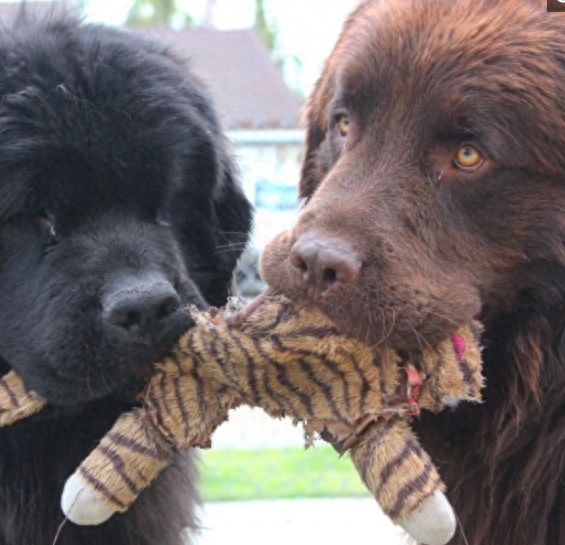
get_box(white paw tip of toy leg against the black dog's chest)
[61,473,115,525]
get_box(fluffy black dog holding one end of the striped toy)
[0,11,250,545]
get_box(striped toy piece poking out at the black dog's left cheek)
[0,371,46,426]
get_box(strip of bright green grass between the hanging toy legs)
[202,445,368,501]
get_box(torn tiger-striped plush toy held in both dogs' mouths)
[0,297,483,545]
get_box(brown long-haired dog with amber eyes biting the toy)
[262,0,565,545]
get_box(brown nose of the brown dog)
[290,235,361,297]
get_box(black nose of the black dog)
[103,279,180,330]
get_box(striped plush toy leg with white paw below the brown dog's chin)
[351,419,456,545]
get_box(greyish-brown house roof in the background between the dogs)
[134,27,302,129]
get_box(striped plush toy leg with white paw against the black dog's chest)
[61,409,172,525]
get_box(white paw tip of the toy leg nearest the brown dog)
[399,490,456,545]
